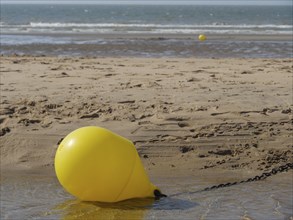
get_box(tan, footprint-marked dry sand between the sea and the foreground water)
[0,56,293,182]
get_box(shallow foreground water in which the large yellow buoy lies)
[1,171,293,220]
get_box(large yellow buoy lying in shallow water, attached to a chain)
[55,126,160,202]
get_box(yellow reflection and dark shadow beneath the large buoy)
[50,198,197,220]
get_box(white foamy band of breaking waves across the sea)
[0,22,293,34]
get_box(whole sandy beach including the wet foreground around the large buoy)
[0,56,293,219]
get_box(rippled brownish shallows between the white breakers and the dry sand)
[0,34,293,58]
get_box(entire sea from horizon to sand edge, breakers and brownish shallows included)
[0,4,292,57]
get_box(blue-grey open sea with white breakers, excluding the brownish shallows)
[0,4,292,35]
